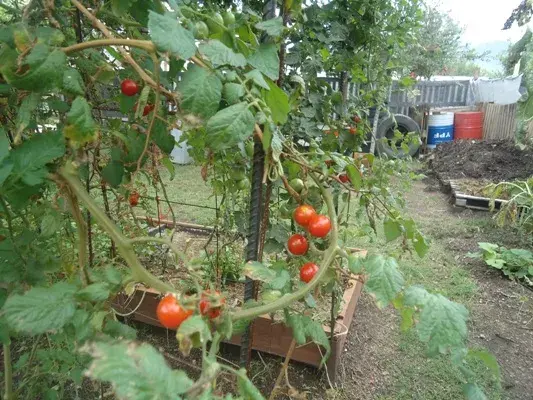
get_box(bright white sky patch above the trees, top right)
[438,0,525,45]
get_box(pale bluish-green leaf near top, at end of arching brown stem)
[148,10,196,59]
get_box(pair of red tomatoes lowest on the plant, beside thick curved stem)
[156,290,226,329]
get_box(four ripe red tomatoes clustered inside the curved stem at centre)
[287,204,331,283]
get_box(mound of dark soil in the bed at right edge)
[429,140,533,183]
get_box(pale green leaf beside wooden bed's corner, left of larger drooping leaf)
[365,255,404,308]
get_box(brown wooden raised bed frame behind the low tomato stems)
[113,277,363,381]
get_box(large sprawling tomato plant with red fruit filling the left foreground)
[0,0,494,400]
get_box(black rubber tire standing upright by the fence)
[376,114,420,158]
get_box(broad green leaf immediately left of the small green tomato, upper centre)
[178,65,222,118]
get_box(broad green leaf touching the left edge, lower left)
[3,282,76,335]
